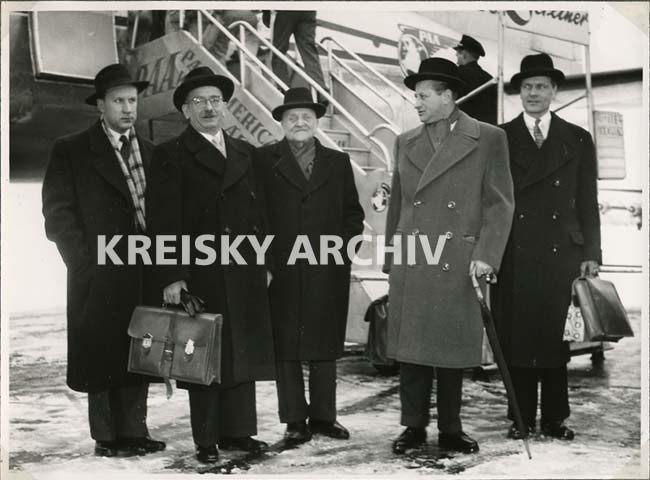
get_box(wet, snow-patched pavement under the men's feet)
[8,310,648,479]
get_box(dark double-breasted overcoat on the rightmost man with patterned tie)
[492,114,601,368]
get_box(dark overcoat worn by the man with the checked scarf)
[43,121,153,392]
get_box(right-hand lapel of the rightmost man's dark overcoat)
[521,114,575,188]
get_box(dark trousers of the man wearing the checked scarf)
[88,383,149,442]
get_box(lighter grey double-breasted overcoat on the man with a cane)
[386,112,514,368]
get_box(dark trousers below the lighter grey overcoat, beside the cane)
[399,363,463,434]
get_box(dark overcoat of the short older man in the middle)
[254,139,364,360]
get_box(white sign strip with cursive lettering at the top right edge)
[496,10,589,45]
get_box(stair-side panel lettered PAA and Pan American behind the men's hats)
[129,31,282,145]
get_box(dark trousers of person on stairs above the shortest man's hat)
[271,10,327,88]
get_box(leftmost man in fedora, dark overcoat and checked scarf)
[43,64,165,457]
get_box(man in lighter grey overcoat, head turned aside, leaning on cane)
[384,58,514,454]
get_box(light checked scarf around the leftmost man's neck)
[102,120,147,232]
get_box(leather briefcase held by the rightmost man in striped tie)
[573,277,634,342]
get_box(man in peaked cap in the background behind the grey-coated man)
[454,35,497,125]
